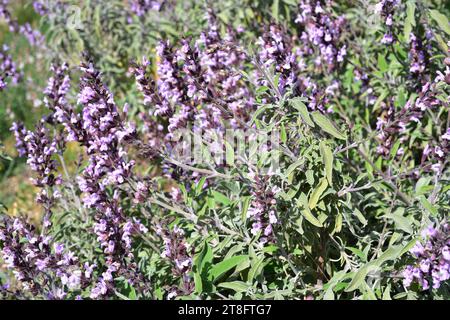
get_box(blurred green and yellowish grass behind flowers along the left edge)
[0,0,48,225]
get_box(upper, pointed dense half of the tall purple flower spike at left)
[76,60,135,188]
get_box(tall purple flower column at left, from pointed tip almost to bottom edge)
[77,63,144,299]
